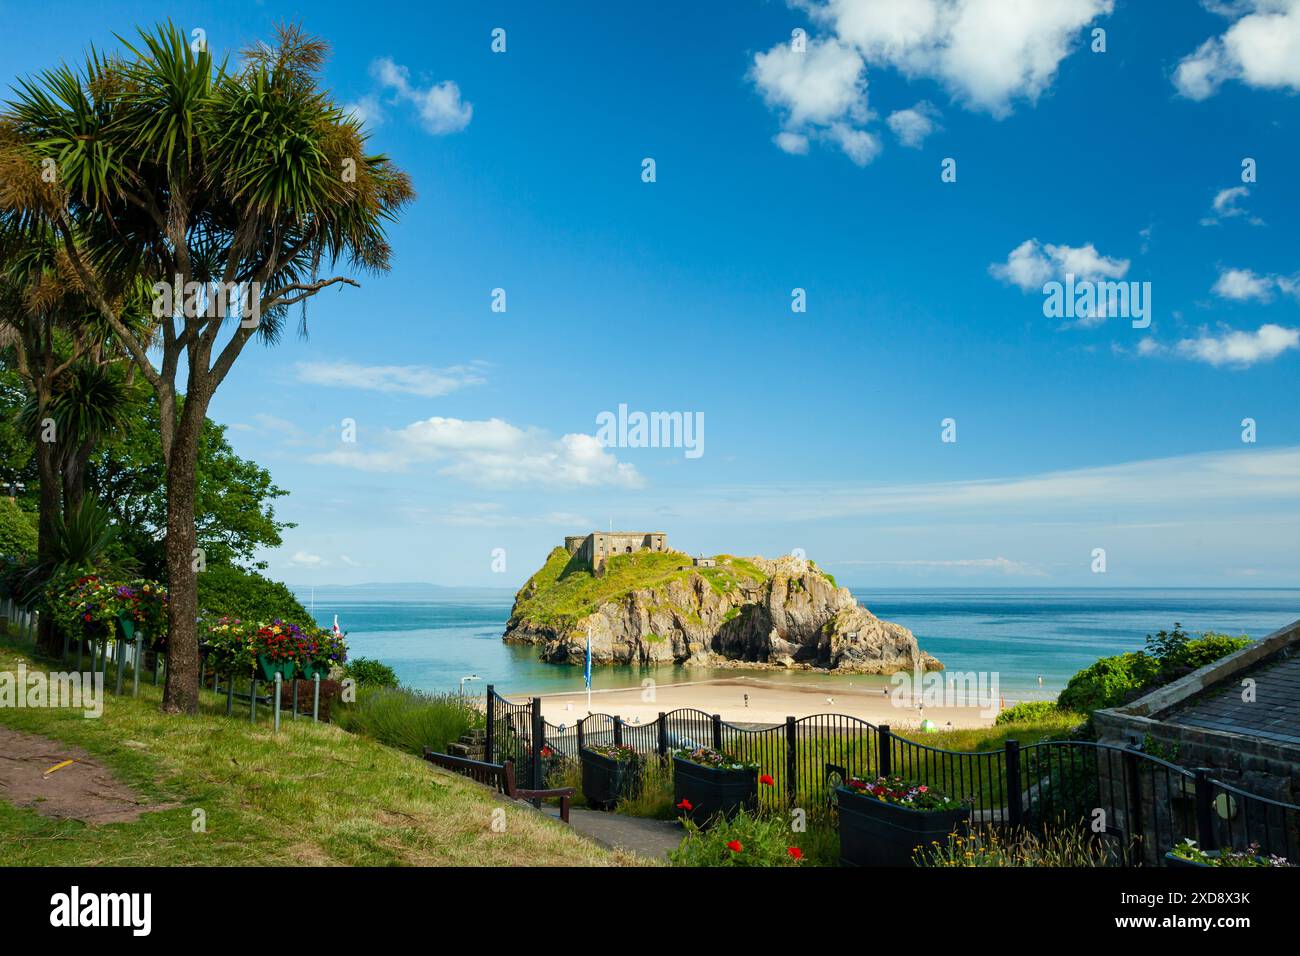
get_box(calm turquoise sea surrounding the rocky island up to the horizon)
[299,588,1300,698]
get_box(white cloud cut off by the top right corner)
[1174,0,1300,100]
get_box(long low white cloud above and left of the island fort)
[311,416,642,488]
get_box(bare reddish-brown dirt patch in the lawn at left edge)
[0,727,174,825]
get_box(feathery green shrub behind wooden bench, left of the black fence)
[332,687,486,754]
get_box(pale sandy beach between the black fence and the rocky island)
[512,675,1013,731]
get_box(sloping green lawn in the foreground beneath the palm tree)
[0,632,629,866]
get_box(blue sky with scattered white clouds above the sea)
[0,0,1300,587]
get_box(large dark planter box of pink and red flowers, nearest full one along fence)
[835,787,971,866]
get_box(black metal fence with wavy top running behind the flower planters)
[488,687,1300,865]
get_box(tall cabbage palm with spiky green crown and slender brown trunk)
[0,23,413,713]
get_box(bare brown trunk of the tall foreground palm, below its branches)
[163,395,207,714]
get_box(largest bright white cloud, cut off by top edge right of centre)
[798,0,1114,116]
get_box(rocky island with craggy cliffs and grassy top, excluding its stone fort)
[504,551,943,674]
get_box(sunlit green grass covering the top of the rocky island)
[515,548,766,628]
